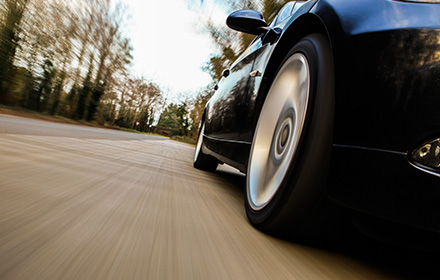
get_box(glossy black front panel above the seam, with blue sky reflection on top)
[312,0,440,152]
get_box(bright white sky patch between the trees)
[124,0,227,102]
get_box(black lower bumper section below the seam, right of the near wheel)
[330,146,440,232]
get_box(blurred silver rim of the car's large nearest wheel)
[246,53,310,211]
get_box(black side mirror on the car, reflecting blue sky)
[226,10,267,35]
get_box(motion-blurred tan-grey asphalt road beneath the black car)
[0,115,438,279]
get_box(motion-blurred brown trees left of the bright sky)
[0,0,164,131]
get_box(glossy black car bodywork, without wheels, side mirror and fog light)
[205,0,440,232]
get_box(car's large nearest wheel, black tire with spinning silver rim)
[245,34,334,241]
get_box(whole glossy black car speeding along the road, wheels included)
[194,0,440,246]
